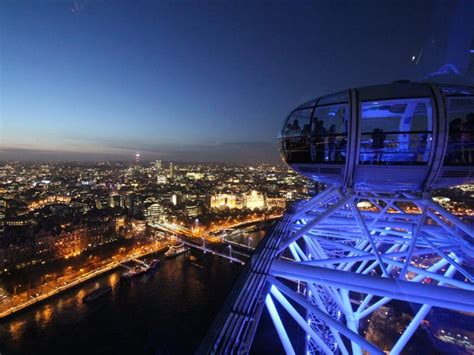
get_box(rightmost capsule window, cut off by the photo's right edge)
[444,97,474,165]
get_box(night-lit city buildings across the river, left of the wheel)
[0,159,308,314]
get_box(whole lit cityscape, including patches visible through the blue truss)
[0,161,474,349]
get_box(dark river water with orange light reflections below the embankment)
[0,231,265,355]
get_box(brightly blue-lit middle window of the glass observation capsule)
[359,98,433,165]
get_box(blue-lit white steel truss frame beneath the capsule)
[264,187,474,354]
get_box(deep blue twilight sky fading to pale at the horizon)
[0,0,472,162]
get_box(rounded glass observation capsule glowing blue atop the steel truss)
[279,81,474,192]
